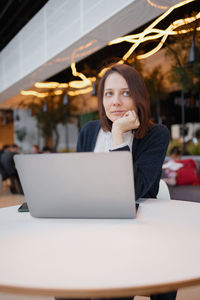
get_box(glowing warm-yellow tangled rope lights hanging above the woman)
[21,0,197,98]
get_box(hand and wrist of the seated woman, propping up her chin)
[112,110,140,147]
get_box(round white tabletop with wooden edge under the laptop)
[0,199,200,298]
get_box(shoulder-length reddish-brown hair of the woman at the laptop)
[98,64,153,139]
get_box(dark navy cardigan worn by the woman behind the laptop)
[77,121,169,199]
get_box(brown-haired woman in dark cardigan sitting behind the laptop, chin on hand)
[57,65,176,300]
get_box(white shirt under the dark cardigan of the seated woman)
[94,128,134,152]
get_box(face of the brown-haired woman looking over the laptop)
[103,72,137,122]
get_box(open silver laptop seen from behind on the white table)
[14,151,136,218]
